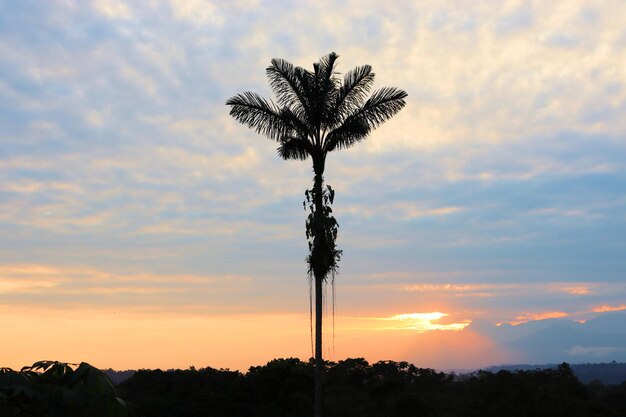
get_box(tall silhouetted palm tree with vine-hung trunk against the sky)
[226,52,407,417]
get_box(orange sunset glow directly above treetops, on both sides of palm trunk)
[0,306,478,371]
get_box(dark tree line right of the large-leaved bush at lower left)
[118,358,626,417]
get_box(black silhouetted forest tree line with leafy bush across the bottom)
[0,358,626,417]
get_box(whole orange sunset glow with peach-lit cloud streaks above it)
[0,265,626,371]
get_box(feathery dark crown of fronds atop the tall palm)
[226,52,407,175]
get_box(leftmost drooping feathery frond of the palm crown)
[226,91,292,140]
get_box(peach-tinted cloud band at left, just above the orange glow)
[0,264,255,314]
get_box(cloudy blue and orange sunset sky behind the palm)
[0,0,626,370]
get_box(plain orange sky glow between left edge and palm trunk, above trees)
[0,308,309,370]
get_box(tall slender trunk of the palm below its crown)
[313,156,326,417]
